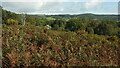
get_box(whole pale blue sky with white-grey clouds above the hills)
[2,0,118,14]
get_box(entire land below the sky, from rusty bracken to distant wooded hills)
[2,9,120,67]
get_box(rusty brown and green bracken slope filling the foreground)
[2,25,120,67]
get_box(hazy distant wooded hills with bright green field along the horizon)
[33,13,118,20]
